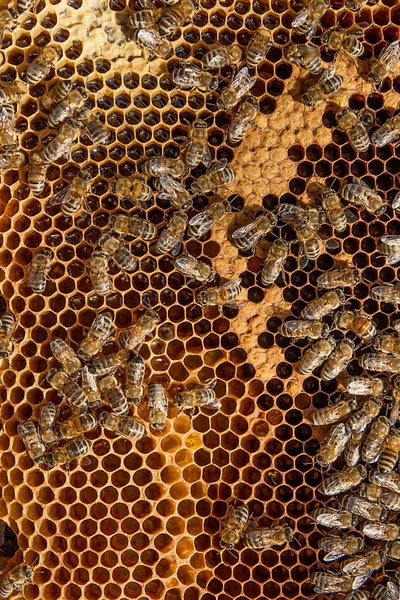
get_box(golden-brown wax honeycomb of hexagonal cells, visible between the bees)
[0,0,400,600]
